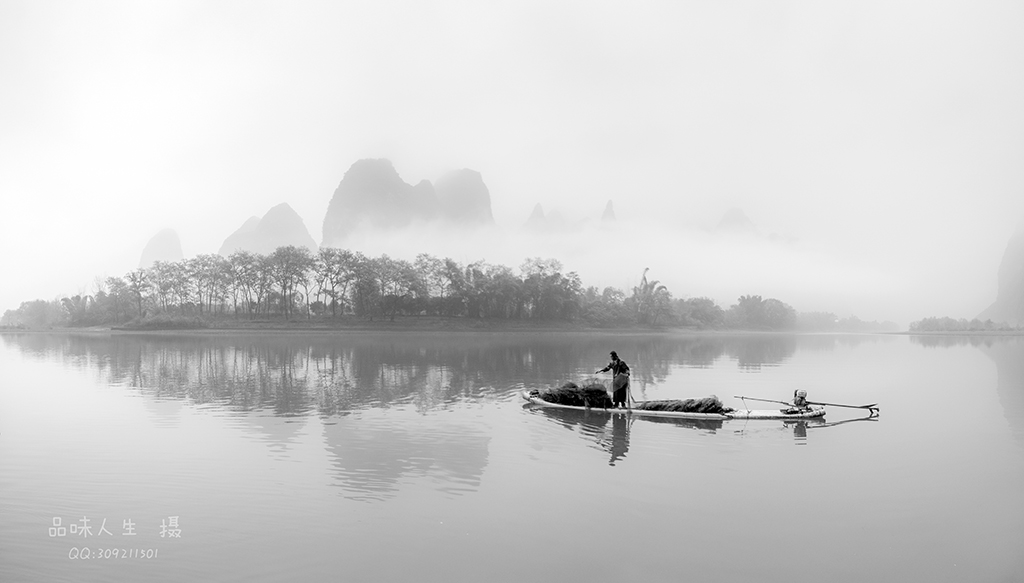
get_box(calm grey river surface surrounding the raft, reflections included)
[0,334,1024,583]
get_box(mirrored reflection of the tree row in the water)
[0,333,888,416]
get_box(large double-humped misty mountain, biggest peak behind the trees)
[324,159,495,247]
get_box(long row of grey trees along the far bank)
[0,246,835,330]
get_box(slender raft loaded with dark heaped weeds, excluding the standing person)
[522,382,825,419]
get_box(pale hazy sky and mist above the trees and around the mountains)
[0,0,1024,324]
